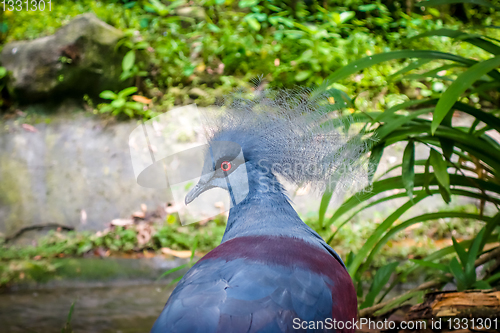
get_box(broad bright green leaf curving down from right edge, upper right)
[431,56,500,134]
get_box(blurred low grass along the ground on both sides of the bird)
[0,206,484,286]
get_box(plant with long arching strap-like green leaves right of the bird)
[320,0,500,312]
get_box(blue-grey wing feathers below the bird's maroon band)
[151,259,332,333]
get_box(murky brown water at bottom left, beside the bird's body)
[0,283,173,333]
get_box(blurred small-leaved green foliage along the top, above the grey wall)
[3,0,494,113]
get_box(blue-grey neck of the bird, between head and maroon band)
[222,165,309,242]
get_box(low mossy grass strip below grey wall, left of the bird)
[0,215,225,287]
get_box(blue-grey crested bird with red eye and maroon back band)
[151,89,365,333]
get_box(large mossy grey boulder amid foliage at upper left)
[0,13,126,102]
